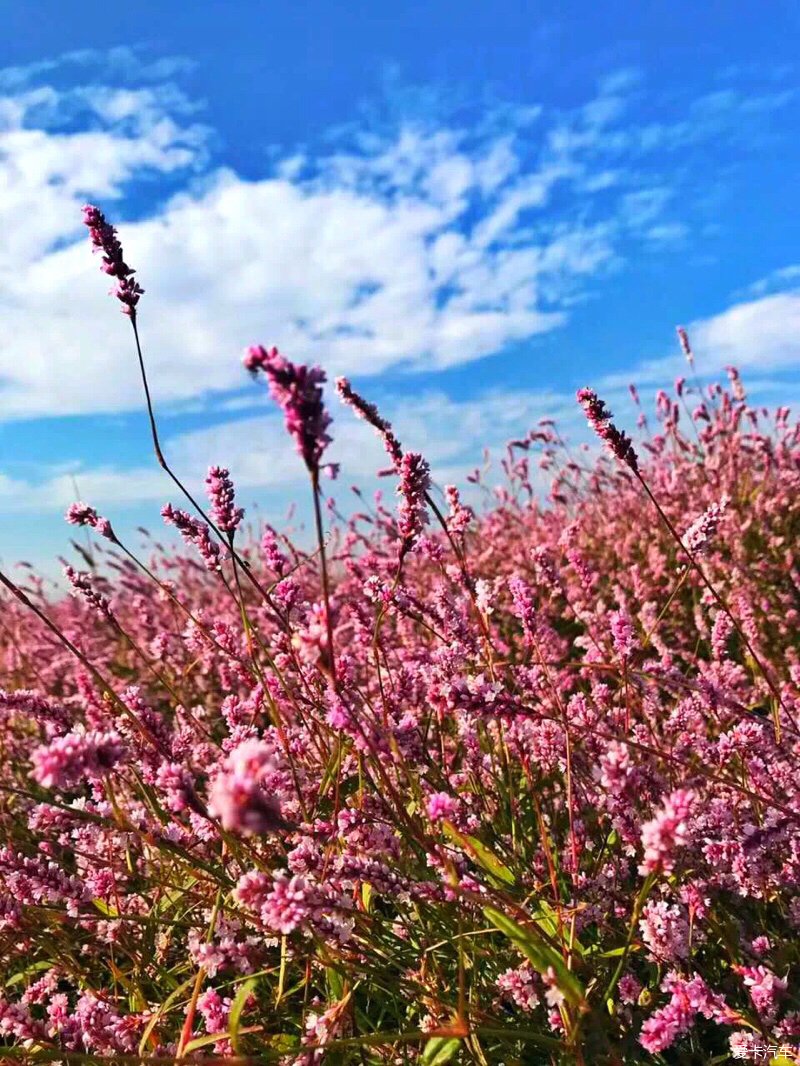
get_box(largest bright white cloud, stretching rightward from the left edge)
[0,52,738,418]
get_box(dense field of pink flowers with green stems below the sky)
[0,210,800,1064]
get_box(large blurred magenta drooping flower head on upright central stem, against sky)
[244,344,331,472]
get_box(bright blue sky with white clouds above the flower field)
[0,0,800,568]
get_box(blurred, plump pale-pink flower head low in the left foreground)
[208,738,287,836]
